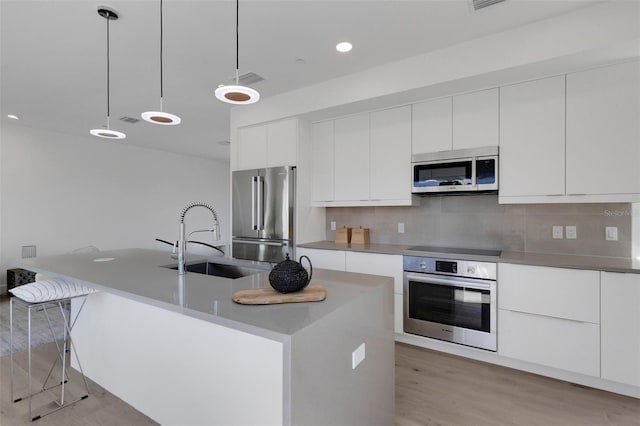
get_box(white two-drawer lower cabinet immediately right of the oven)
[498,263,600,377]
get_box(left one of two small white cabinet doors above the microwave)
[411,98,452,154]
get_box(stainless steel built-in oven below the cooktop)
[404,256,497,351]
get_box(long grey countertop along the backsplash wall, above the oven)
[298,241,640,274]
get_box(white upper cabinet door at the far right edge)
[567,62,640,194]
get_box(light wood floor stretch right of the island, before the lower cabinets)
[396,343,640,426]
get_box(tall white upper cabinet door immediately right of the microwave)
[500,76,565,197]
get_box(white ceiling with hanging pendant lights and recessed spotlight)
[0,0,594,160]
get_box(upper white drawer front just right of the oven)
[498,263,600,324]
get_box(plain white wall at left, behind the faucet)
[0,125,230,293]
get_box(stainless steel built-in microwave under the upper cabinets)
[411,146,498,195]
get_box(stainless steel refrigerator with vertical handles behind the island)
[231,167,296,262]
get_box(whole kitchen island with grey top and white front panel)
[19,249,394,425]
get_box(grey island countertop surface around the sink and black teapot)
[15,249,393,340]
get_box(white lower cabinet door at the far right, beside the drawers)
[600,272,640,386]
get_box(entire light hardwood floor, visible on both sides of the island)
[0,343,640,426]
